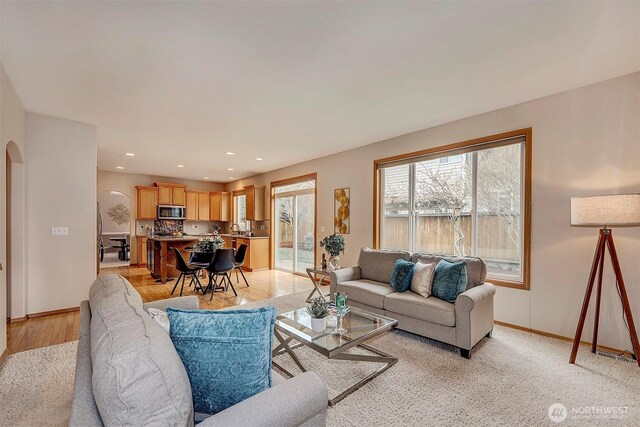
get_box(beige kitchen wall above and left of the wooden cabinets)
[98,171,224,262]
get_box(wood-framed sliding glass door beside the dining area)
[271,174,316,274]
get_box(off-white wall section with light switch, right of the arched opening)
[26,113,97,314]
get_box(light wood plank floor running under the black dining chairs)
[7,267,313,354]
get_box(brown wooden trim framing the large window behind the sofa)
[373,128,532,290]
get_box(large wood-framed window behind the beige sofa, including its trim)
[375,129,531,288]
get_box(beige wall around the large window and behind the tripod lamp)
[226,73,640,348]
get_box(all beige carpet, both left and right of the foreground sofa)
[0,291,640,426]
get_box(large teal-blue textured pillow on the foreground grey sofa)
[167,307,276,414]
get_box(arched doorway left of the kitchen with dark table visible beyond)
[97,190,131,268]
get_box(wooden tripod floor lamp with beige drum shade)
[569,194,640,366]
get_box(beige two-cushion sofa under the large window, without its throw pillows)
[331,248,496,359]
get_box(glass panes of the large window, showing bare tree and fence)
[381,143,523,276]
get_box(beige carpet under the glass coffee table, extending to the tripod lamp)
[238,292,640,426]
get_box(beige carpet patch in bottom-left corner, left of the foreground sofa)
[0,341,78,427]
